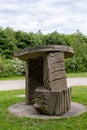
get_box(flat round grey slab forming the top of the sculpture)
[14,45,74,60]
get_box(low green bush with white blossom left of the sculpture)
[0,57,25,77]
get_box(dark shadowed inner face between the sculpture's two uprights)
[28,57,43,104]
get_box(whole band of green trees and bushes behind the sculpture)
[0,27,87,77]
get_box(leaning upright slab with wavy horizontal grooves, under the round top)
[47,52,67,92]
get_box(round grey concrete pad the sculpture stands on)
[9,102,87,119]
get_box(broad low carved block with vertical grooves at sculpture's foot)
[34,88,71,116]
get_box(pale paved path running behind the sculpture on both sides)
[0,78,87,91]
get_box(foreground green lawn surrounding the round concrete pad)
[0,86,87,130]
